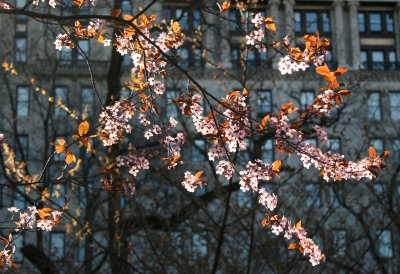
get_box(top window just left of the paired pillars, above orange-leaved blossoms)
[294,10,331,34]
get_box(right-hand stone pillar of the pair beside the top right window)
[348,0,360,69]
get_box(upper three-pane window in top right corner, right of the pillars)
[358,11,394,36]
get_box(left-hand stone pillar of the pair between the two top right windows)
[333,0,347,67]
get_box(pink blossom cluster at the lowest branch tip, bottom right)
[271,216,325,266]
